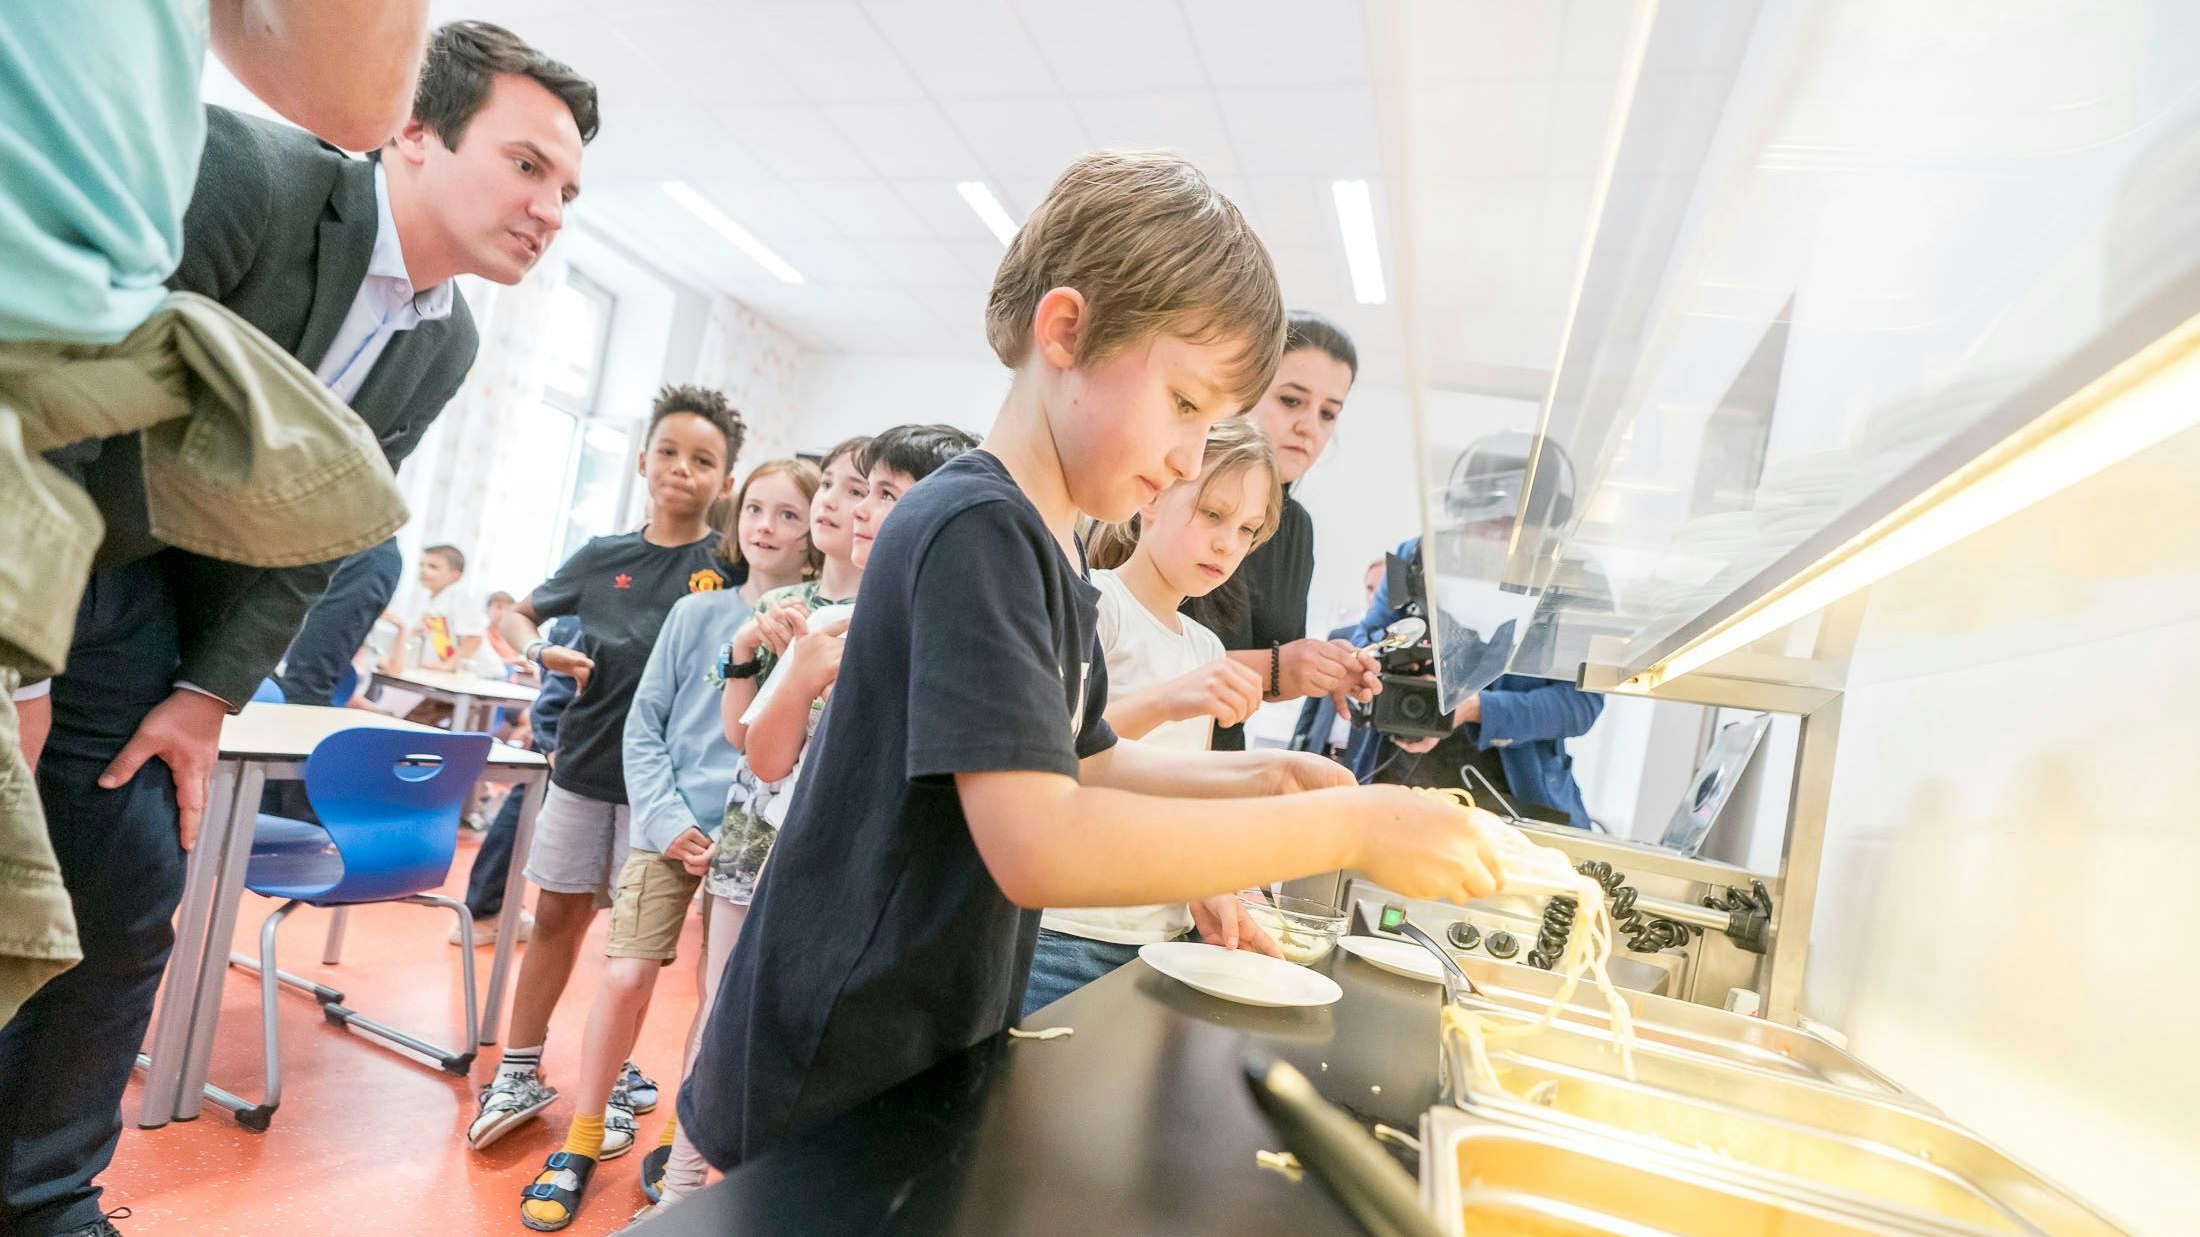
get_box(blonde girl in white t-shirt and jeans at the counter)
[1023,416,1284,1017]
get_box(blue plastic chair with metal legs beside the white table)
[207,726,491,1131]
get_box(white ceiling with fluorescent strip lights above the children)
[413,0,1628,383]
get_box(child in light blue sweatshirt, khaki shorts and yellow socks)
[521,460,818,1230]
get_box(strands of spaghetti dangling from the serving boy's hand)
[1421,788,1635,1092]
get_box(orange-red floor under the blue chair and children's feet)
[101,832,702,1237]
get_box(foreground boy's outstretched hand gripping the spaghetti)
[1353,786,1511,902]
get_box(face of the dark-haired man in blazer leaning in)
[385,73,581,284]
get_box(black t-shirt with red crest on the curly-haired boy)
[528,533,741,803]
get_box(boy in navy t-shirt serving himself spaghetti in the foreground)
[680,152,1503,1169]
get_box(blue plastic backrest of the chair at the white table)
[306,726,491,902]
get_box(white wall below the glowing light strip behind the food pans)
[1804,416,2200,1235]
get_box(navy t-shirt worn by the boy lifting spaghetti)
[680,451,1115,1169]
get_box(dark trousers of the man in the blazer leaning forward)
[0,563,185,1237]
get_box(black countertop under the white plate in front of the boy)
[636,937,1441,1237]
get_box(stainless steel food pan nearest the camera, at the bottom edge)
[1421,1109,1982,1237]
